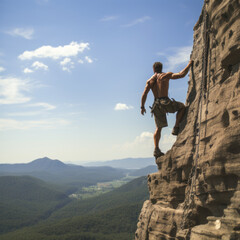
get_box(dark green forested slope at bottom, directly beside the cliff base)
[0,177,149,240]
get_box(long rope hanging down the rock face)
[181,0,209,229]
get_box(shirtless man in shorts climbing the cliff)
[141,60,193,158]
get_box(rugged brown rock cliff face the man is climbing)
[135,0,240,240]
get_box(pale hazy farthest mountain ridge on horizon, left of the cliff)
[83,158,155,169]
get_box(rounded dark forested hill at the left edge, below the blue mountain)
[0,176,70,233]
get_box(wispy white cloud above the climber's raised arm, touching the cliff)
[158,46,192,71]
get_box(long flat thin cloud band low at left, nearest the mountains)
[0,118,70,131]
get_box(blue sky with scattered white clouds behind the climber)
[0,0,203,164]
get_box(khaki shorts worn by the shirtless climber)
[151,98,185,128]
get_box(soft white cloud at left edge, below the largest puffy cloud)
[0,77,31,104]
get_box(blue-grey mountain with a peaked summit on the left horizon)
[0,157,127,187]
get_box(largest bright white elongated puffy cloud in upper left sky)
[18,42,89,60]
